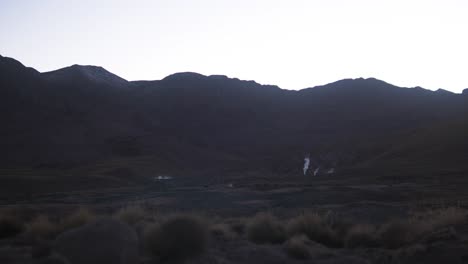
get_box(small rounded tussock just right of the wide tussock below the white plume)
[345,224,379,248]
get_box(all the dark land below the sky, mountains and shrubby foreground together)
[0,56,468,263]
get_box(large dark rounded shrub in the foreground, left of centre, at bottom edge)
[145,215,208,261]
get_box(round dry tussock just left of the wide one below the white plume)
[246,213,286,244]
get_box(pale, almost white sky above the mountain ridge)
[0,0,468,92]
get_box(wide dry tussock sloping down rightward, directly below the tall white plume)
[287,213,343,247]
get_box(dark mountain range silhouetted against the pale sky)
[0,54,467,180]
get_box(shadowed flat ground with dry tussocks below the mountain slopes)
[0,168,468,264]
